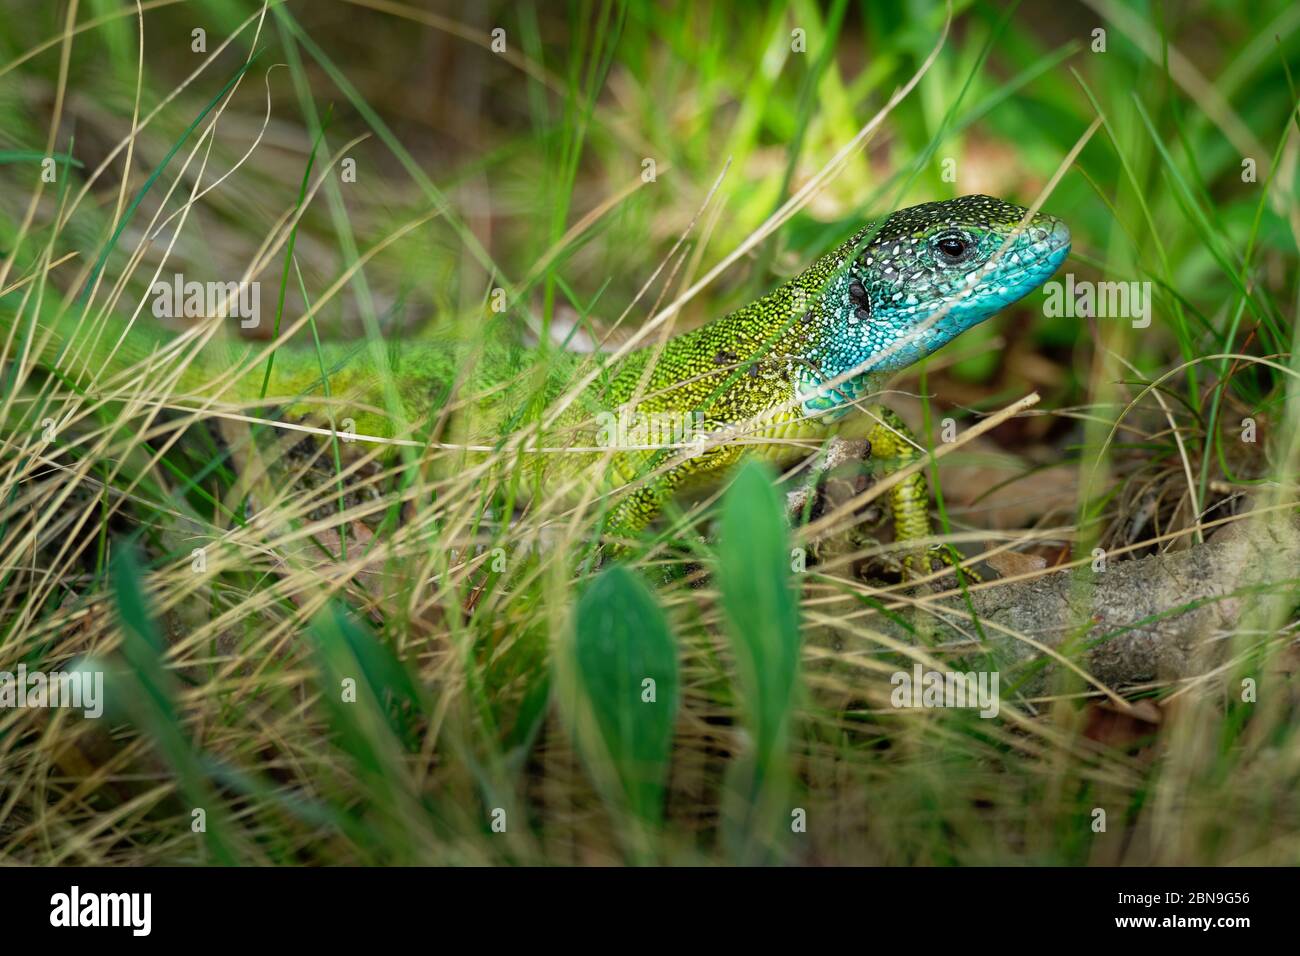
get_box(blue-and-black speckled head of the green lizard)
[840,195,1070,372]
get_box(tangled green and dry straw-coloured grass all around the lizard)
[0,0,1300,864]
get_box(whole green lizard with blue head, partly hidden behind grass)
[0,195,1070,571]
